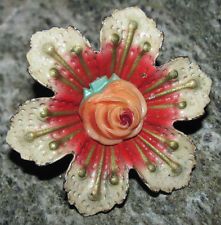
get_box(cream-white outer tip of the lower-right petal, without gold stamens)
[137,131,195,192]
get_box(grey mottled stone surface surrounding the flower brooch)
[0,0,221,225]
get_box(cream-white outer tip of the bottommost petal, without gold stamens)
[65,162,128,216]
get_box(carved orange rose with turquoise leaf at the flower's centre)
[79,74,147,145]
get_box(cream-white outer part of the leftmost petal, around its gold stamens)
[6,98,83,165]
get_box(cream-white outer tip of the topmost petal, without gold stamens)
[100,7,163,59]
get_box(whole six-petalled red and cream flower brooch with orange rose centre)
[7,7,211,215]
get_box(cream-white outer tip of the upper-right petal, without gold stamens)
[163,57,212,119]
